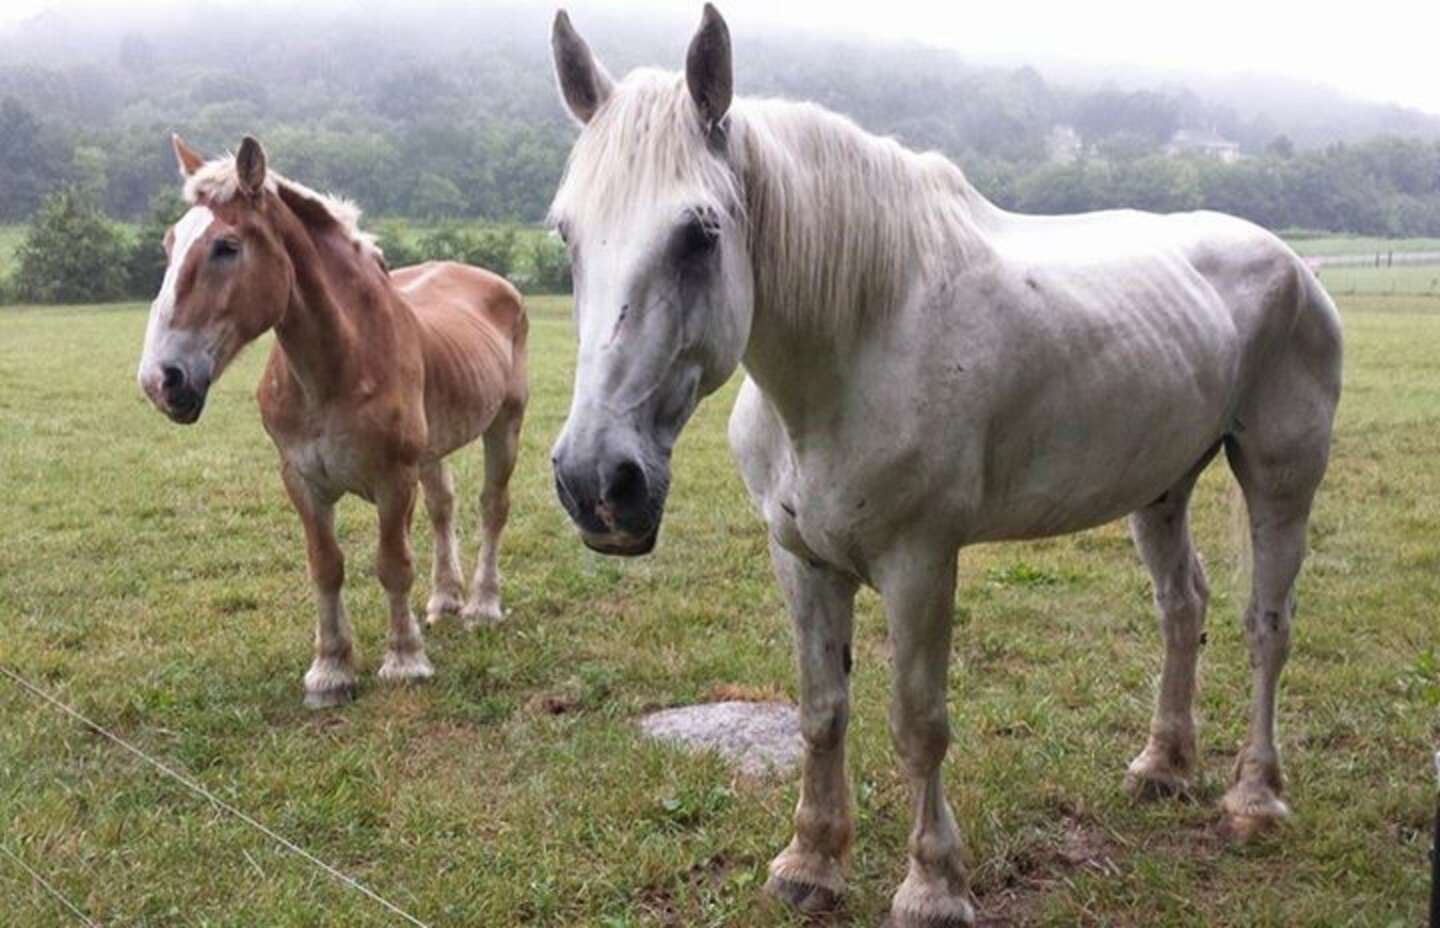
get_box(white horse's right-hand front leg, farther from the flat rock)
[877,550,975,928]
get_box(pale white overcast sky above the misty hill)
[11,0,1440,114]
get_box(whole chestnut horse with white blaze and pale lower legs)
[138,137,527,708]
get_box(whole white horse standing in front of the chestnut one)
[541,6,1341,925]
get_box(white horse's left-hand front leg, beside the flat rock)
[765,539,855,912]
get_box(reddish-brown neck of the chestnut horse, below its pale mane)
[275,222,406,398]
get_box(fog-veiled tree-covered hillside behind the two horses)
[0,6,1440,304]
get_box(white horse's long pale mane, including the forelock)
[550,69,992,333]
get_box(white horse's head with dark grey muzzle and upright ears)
[552,4,755,555]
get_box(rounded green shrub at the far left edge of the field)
[14,187,130,303]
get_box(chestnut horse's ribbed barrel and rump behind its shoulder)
[390,261,528,455]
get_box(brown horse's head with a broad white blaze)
[137,135,294,424]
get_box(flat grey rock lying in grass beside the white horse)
[639,702,805,777]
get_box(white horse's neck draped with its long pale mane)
[740,104,996,419]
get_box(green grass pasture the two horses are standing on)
[0,297,1440,928]
